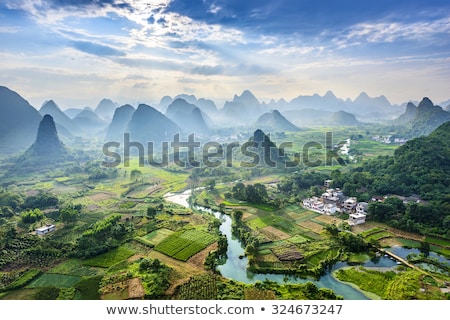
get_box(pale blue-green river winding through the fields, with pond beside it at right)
[164,190,397,300]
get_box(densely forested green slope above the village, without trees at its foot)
[341,121,450,200]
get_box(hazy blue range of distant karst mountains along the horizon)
[0,87,450,154]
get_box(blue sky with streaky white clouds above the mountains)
[0,0,450,109]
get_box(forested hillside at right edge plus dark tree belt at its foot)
[332,121,450,237]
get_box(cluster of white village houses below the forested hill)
[302,180,369,225]
